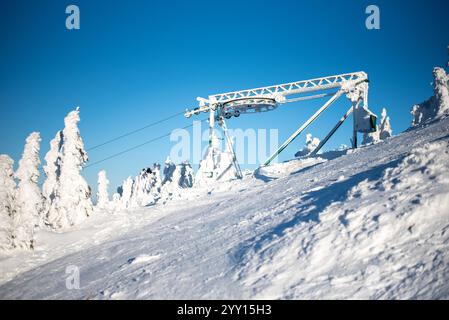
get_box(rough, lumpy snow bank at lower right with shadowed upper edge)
[240,141,449,299]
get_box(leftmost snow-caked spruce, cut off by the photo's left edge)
[0,154,16,250]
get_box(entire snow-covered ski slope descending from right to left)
[0,118,449,299]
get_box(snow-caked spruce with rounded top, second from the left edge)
[13,132,43,249]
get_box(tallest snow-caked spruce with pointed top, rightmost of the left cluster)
[48,108,93,229]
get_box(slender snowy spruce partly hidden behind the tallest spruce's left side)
[42,131,63,220]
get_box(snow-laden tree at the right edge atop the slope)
[411,67,449,126]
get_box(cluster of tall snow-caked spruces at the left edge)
[0,108,93,249]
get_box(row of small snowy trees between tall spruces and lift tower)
[93,132,238,211]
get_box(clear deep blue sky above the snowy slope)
[0,0,449,192]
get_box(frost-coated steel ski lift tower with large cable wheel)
[184,71,377,166]
